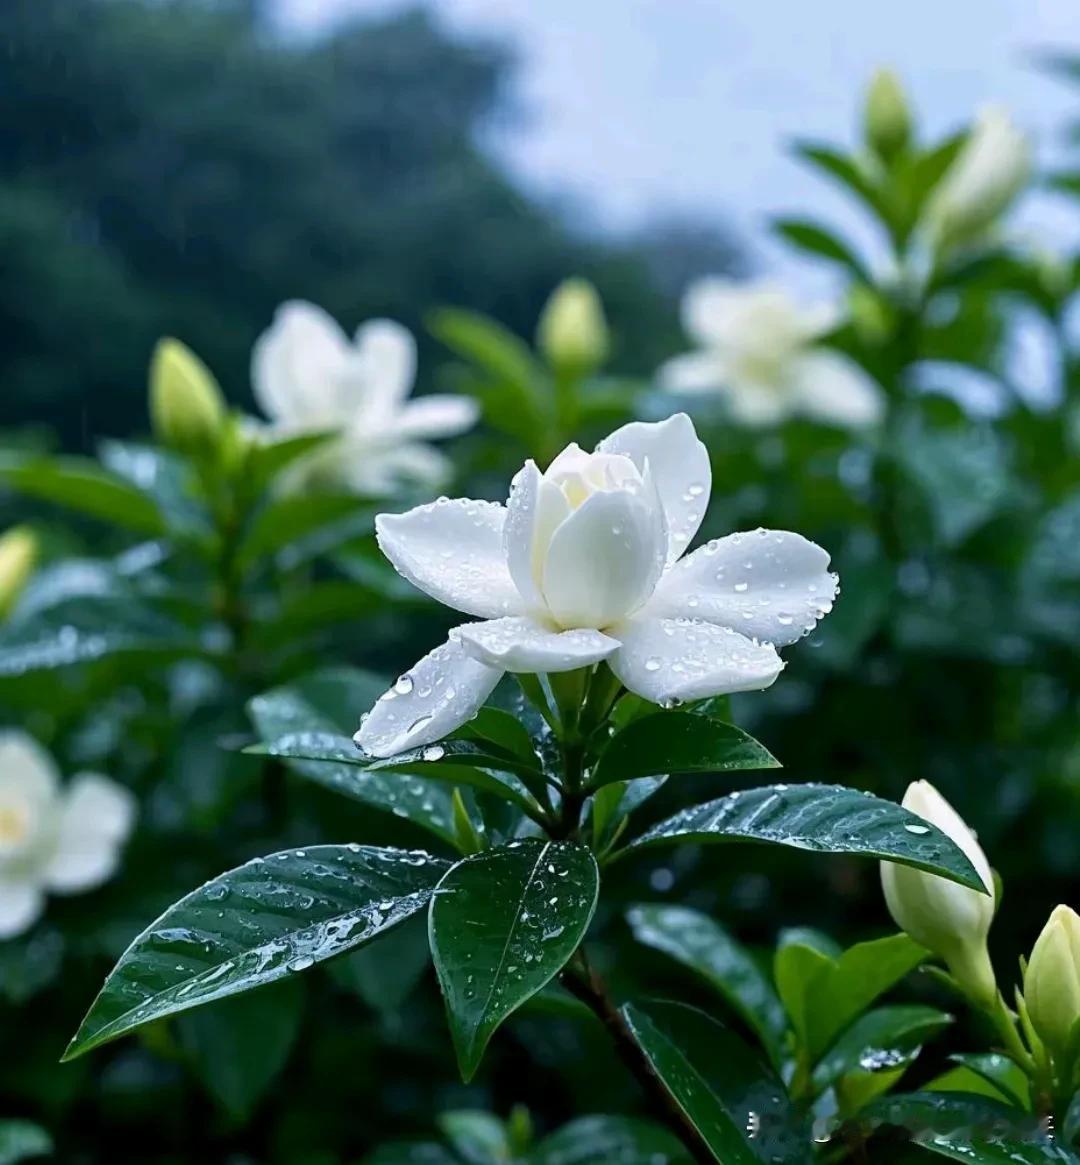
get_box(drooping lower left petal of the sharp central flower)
[357,638,502,756]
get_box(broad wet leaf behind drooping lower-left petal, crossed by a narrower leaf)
[248,668,454,846]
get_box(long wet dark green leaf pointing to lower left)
[64,845,447,1060]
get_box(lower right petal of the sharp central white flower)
[608,617,784,704]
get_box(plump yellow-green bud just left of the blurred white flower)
[150,339,225,454]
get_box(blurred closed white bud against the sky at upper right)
[926,106,1031,243]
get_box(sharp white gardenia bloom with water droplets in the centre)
[357,412,837,756]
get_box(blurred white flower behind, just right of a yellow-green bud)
[252,301,479,496]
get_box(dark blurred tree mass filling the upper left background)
[0,0,703,444]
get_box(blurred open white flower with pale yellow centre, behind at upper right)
[659,278,884,429]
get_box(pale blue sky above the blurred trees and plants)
[277,0,1080,279]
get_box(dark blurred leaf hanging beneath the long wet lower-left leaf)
[177,979,304,1122]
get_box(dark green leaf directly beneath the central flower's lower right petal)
[588,712,781,789]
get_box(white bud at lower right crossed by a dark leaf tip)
[881,781,997,1007]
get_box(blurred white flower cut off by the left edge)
[0,732,135,939]
